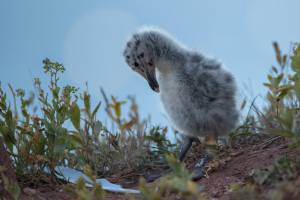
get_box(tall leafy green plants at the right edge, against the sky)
[259,43,300,147]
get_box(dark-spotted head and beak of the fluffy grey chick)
[123,28,163,92]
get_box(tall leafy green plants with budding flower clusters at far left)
[0,59,81,183]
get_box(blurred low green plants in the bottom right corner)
[229,156,300,200]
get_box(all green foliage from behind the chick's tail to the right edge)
[230,42,300,147]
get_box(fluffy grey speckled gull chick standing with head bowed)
[123,28,238,180]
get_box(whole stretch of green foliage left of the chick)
[0,59,176,188]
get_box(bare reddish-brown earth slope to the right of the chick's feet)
[199,139,295,200]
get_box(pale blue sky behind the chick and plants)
[0,0,300,137]
